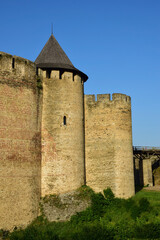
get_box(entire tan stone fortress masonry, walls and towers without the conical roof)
[0,46,134,229]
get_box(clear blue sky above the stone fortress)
[0,0,160,146]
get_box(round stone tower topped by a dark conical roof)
[35,35,88,196]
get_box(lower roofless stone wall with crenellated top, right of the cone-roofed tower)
[85,94,134,198]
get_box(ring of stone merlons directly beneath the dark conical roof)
[38,68,84,82]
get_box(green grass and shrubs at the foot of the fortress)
[9,187,160,240]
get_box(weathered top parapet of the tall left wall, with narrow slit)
[0,52,36,79]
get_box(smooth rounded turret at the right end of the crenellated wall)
[112,93,135,198]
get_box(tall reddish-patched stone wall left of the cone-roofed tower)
[0,52,40,229]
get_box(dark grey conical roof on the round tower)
[35,34,88,81]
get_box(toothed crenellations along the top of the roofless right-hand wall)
[85,93,131,104]
